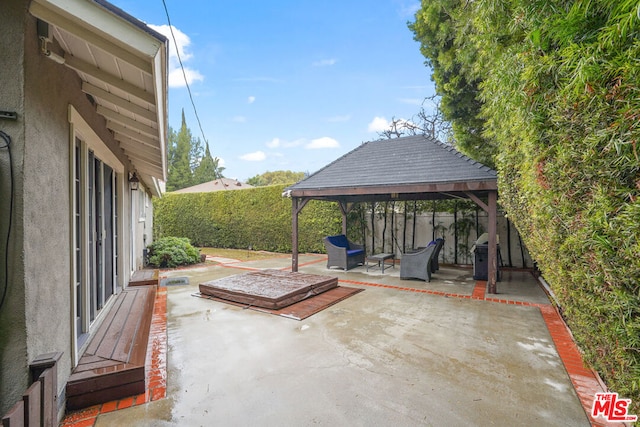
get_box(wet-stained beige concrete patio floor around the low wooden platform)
[70,255,591,426]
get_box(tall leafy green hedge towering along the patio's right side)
[413,0,640,413]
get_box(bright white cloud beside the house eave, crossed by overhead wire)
[149,25,204,87]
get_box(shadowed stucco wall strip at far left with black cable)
[0,2,33,413]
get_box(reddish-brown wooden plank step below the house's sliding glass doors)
[66,285,156,410]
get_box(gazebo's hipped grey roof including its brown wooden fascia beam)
[286,135,497,200]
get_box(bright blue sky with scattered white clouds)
[111,0,434,181]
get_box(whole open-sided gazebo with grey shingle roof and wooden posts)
[284,135,498,294]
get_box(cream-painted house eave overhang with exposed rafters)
[29,0,168,195]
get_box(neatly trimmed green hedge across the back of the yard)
[153,185,342,253]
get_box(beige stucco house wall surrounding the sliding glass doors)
[0,0,165,415]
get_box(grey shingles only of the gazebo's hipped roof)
[288,135,497,190]
